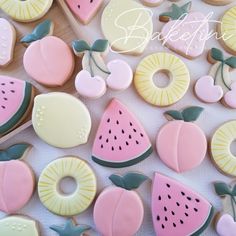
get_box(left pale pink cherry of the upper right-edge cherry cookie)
[195,76,223,103]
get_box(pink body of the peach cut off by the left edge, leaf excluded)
[0,160,34,214]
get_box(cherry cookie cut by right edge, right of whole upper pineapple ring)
[195,48,236,109]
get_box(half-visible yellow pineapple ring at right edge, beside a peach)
[211,120,236,177]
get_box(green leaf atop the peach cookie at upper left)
[20,20,53,43]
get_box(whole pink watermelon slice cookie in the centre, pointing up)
[92,99,152,168]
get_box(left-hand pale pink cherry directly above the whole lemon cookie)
[75,70,106,99]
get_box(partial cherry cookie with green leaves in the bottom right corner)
[214,182,236,236]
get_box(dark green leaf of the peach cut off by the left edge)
[0,143,31,161]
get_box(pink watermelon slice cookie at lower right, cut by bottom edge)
[152,173,214,236]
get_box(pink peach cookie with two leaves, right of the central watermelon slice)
[156,107,207,172]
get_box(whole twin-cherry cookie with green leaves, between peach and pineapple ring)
[72,39,133,99]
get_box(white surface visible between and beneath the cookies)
[0,0,236,236]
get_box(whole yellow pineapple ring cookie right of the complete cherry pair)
[134,52,190,107]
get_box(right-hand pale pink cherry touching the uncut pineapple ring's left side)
[106,60,133,90]
